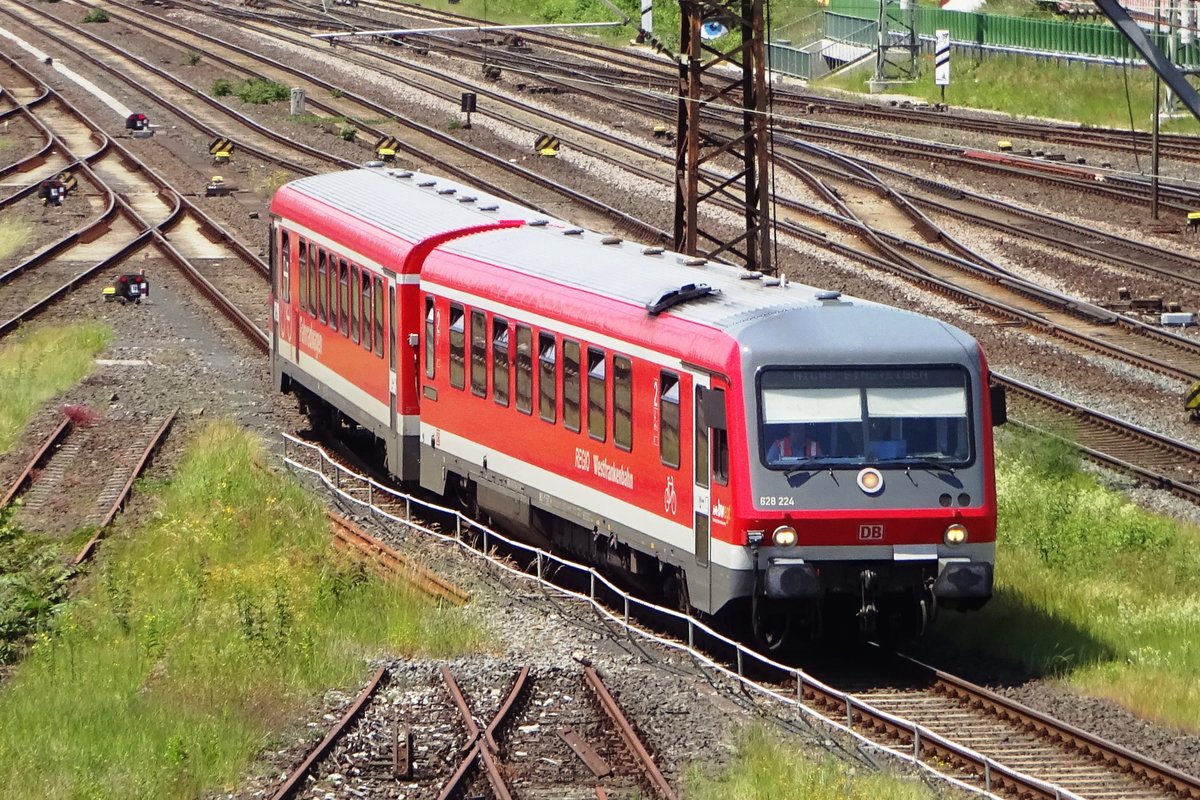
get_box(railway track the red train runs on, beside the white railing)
[278,438,1200,800]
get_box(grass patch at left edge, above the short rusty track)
[0,323,113,453]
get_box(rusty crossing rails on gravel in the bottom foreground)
[272,663,676,800]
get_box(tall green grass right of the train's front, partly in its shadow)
[932,431,1200,733]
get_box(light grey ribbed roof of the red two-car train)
[281,167,973,349]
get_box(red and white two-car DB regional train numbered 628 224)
[270,167,1004,646]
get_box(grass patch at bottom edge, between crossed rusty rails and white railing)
[683,726,937,800]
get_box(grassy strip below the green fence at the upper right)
[816,50,1200,133]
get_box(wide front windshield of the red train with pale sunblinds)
[758,366,974,469]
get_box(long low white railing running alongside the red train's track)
[283,434,1084,800]
